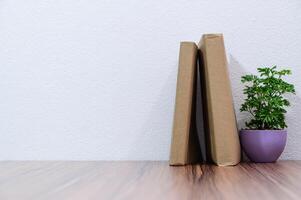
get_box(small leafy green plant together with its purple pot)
[240,66,295,162]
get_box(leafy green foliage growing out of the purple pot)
[240,66,295,130]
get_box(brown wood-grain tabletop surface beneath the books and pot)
[0,161,301,200]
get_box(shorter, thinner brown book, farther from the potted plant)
[169,42,201,165]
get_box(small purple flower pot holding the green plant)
[240,130,287,163]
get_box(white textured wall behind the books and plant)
[0,0,301,160]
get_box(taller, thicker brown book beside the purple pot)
[199,34,241,166]
